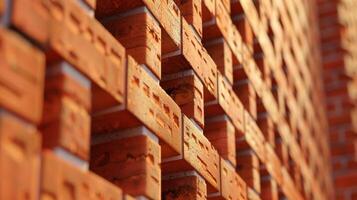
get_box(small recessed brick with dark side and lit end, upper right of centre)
[205,38,233,84]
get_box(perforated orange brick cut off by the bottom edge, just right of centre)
[208,159,247,200]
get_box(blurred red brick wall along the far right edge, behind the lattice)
[319,0,357,200]
